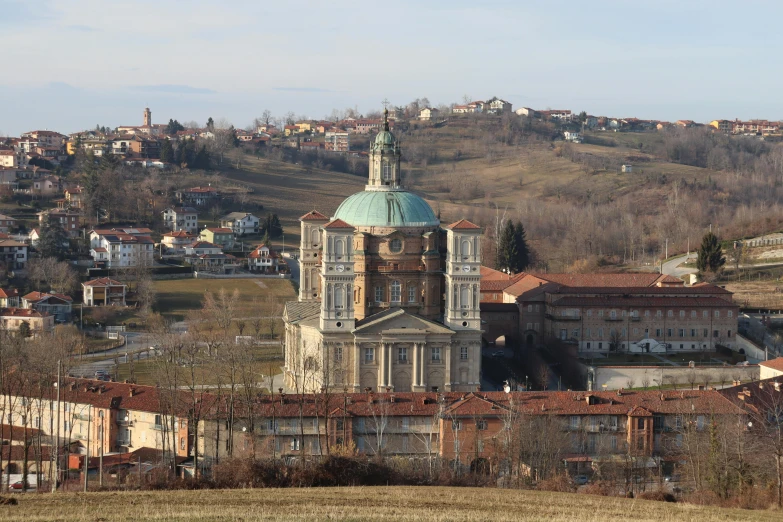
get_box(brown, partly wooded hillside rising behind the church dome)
[207,120,783,270]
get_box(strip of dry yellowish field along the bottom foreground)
[0,487,781,522]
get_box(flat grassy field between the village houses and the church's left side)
[155,279,296,320]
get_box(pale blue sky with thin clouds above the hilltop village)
[0,0,783,136]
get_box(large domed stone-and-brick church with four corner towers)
[283,111,482,392]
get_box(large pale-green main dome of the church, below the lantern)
[332,190,440,227]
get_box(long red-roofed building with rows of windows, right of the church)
[503,274,739,353]
